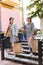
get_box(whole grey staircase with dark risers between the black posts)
[5,42,38,65]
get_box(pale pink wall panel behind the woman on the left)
[1,7,22,32]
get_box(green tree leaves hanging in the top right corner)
[27,0,43,18]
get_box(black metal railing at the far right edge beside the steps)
[38,40,43,65]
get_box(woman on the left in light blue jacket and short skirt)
[6,17,18,56]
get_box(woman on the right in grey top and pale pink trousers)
[26,17,34,55]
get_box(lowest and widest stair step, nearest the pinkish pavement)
[5,57,38,65]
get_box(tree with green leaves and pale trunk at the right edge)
[27,0,43,32]
